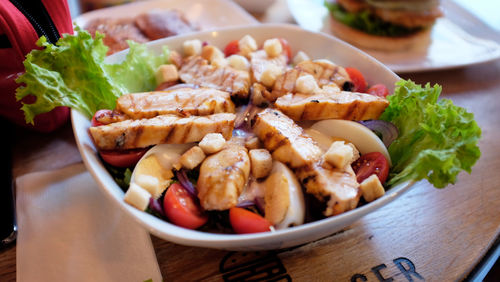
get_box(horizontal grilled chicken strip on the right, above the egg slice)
[275,89,389,121]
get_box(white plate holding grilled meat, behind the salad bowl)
[75,0,259,30]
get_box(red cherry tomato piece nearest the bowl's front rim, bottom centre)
[229,207,271,234]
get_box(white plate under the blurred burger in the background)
[288,0,500,73]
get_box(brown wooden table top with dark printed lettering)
[0,1,500,281]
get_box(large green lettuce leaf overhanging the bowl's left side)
[16,27,168,123]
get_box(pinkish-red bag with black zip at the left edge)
[0,0,73,132]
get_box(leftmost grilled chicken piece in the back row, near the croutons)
[179,56,250,99]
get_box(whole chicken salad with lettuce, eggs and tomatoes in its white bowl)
[17,25,481,250]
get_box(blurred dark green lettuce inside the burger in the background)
[324,1,422,37]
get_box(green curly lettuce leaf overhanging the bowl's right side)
[380,80,481,188]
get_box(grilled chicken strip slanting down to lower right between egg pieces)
[253,109,360,216]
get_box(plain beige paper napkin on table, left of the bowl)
[16,163,162,282]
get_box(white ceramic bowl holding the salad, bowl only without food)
[72,25,413,251]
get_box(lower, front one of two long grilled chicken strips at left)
[90,113,236,150]
